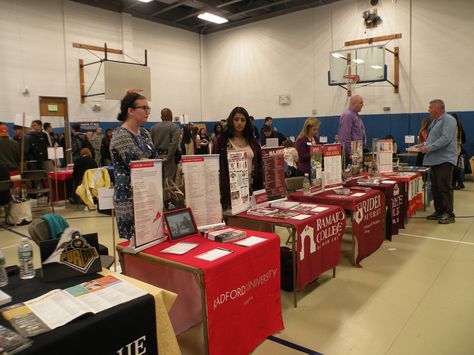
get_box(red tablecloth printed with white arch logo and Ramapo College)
[237,205,346,289]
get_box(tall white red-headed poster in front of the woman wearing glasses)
[130,160,165,251]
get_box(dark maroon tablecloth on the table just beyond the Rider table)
[345,180,408,240]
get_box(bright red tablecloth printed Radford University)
[121,231,284,354]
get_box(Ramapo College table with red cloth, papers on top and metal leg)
[227,204,346,307]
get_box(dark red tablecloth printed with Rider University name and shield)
[288,190,385,265]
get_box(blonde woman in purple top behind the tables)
[296,117,321,176]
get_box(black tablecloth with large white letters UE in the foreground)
[0,270,158,355]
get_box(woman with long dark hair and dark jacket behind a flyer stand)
[212,107,263,210]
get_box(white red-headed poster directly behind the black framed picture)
[181,154,222,226]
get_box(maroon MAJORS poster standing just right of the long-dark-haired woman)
[262,147,286,201]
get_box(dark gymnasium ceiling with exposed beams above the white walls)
[72,0,339,34]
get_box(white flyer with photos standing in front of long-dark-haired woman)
[227,150,250,215]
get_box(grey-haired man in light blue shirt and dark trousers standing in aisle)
[420,99,458,224]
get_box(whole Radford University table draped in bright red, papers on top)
[117,231,283,354]
